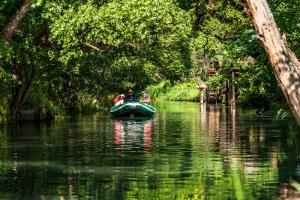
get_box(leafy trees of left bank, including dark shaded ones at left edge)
[0,0,192,122]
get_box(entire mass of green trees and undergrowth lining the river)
[0,0,300,124]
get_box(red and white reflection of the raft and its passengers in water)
[114,119,152,149]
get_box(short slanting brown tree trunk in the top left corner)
[3,0,33,41]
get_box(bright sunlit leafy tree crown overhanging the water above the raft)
[46,0,191,89]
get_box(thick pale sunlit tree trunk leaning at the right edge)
[247,0,300,126]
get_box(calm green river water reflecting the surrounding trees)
[0,102,300,200]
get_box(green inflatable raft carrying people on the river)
[110,102,156,117]
